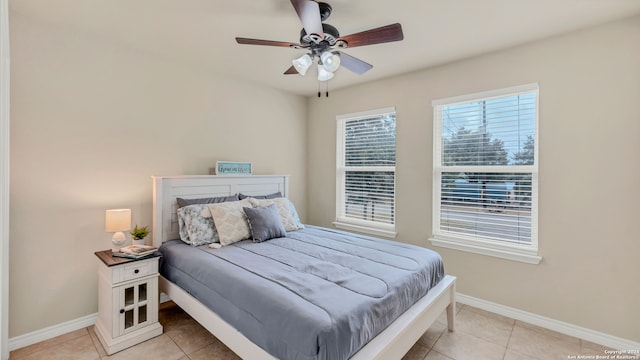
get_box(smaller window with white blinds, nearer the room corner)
[334,108,396,237]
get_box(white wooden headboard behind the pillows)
[151,175,289,247]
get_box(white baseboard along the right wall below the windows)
[456,293,640,350]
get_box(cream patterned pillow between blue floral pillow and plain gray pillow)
[207,199,252,245]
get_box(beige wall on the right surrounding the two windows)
[307,17,640,341]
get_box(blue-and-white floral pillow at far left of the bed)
[178,204,220,246]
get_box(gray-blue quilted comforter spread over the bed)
[160,226,444,360]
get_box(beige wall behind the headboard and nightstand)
[9,13,307,337]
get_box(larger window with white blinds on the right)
[431,84,541,264]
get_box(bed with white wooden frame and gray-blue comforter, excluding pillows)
[152,175,455,359]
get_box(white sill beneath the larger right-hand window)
[429,237,542,265]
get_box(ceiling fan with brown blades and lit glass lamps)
[236,0,404,86]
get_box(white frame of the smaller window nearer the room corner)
[333,107,397,238]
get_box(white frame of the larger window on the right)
[429,83,542,264]
